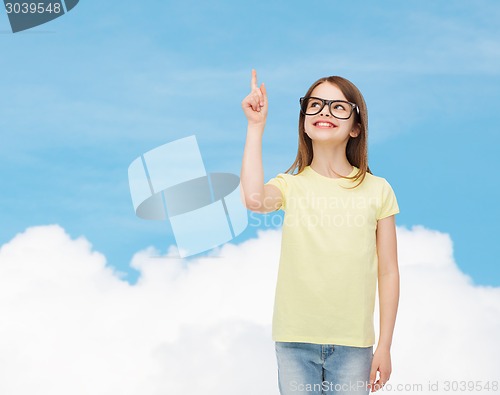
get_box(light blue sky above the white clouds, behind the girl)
[0,0,500,286]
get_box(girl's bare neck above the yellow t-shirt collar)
[310,146,353,178]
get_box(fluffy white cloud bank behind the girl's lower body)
[0,226,500,395]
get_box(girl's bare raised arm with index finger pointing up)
[240,70,282,213]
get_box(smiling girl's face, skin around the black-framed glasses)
[304,82,359,144]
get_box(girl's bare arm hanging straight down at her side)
[370,215,399,392]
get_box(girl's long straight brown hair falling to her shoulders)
[285,76,372,188]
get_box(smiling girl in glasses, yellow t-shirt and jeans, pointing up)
[241,70,399,395]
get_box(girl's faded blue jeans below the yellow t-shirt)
[275,342,373,395]
